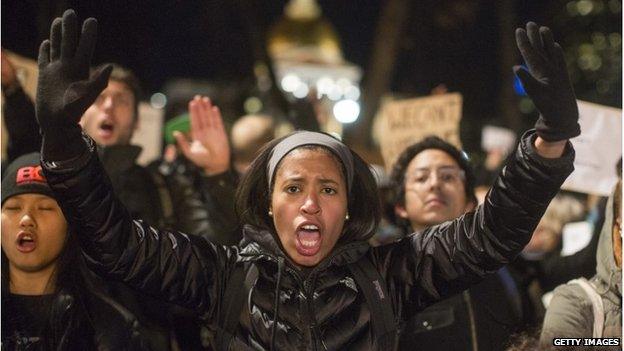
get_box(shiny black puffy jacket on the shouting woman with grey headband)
[43,133,574,350]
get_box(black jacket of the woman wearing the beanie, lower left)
[0,270,156,351]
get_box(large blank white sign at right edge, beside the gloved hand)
[562,101,622,196]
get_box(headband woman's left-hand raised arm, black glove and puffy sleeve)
[36,10,236,316]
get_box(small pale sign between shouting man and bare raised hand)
[130,102,165,166]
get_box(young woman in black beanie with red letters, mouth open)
[2,153,162,350]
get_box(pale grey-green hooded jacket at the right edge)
[540,190,622,350]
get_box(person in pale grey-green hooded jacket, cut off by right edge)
[540,176,622,350]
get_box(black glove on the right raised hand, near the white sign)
[513,22,581,141]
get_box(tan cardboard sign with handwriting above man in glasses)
[378,93,462,171]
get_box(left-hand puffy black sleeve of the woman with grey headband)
[42,134,238,319]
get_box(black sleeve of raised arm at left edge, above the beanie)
[2,86,41,163]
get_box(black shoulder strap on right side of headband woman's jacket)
[348,256,398,350]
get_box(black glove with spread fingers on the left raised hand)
[36,10,112,160]
